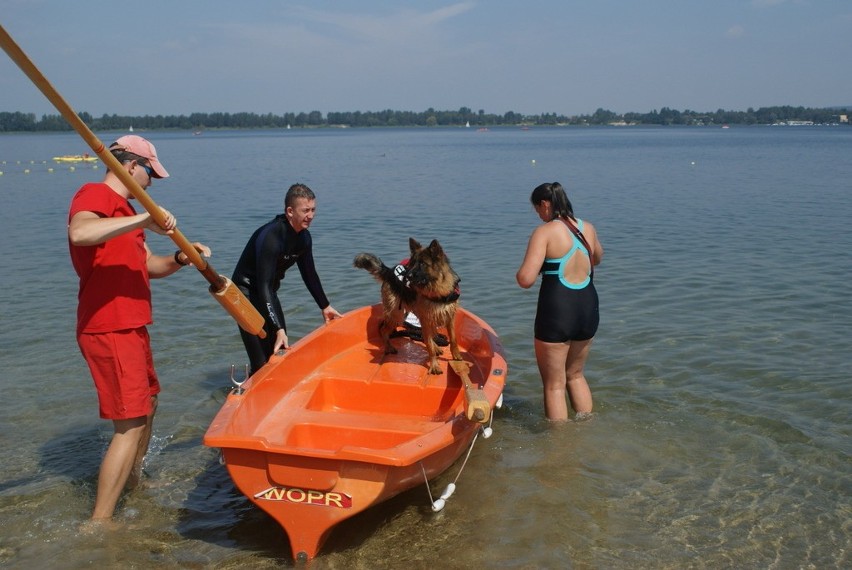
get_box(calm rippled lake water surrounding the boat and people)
[0,127,852,569]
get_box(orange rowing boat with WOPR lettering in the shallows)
[204,305,506,561]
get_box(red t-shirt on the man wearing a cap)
[68,183,152,334]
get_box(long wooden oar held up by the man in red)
[0,25,266,338]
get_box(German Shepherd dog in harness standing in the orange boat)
[353,238,461,374]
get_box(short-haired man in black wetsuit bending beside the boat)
[231,184,341,368]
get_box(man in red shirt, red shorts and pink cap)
[68,135,210,520]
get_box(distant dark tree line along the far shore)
[0,106,850,132]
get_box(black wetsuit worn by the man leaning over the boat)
[231,214,329,374]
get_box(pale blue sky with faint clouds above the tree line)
[0,0,852,116]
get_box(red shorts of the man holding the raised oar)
[77,327,160,420]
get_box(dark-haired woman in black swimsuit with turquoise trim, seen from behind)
[515,182,603,421]
